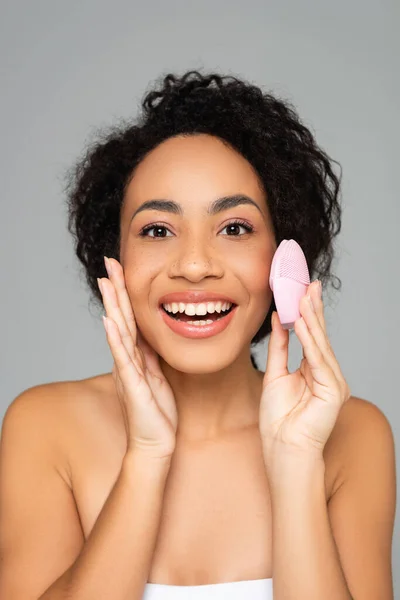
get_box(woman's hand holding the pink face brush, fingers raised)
[259,281,350,459]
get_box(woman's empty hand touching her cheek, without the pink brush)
[97,258,178,459]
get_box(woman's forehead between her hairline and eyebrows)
[125,134,265,209]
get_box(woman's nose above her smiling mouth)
[170,240,223,282]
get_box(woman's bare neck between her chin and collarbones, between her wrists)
[160,352,264,442]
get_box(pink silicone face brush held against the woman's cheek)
[269,240,310,329]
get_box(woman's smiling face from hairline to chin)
[120,134,276,373]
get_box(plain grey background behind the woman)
[0,0,400,597]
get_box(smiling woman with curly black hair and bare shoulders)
[0,71,395,600]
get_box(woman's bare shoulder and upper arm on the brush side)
[328,397,396,600]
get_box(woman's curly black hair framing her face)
[65,70,342,368]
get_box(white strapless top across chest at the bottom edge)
[142,579,273,600]
